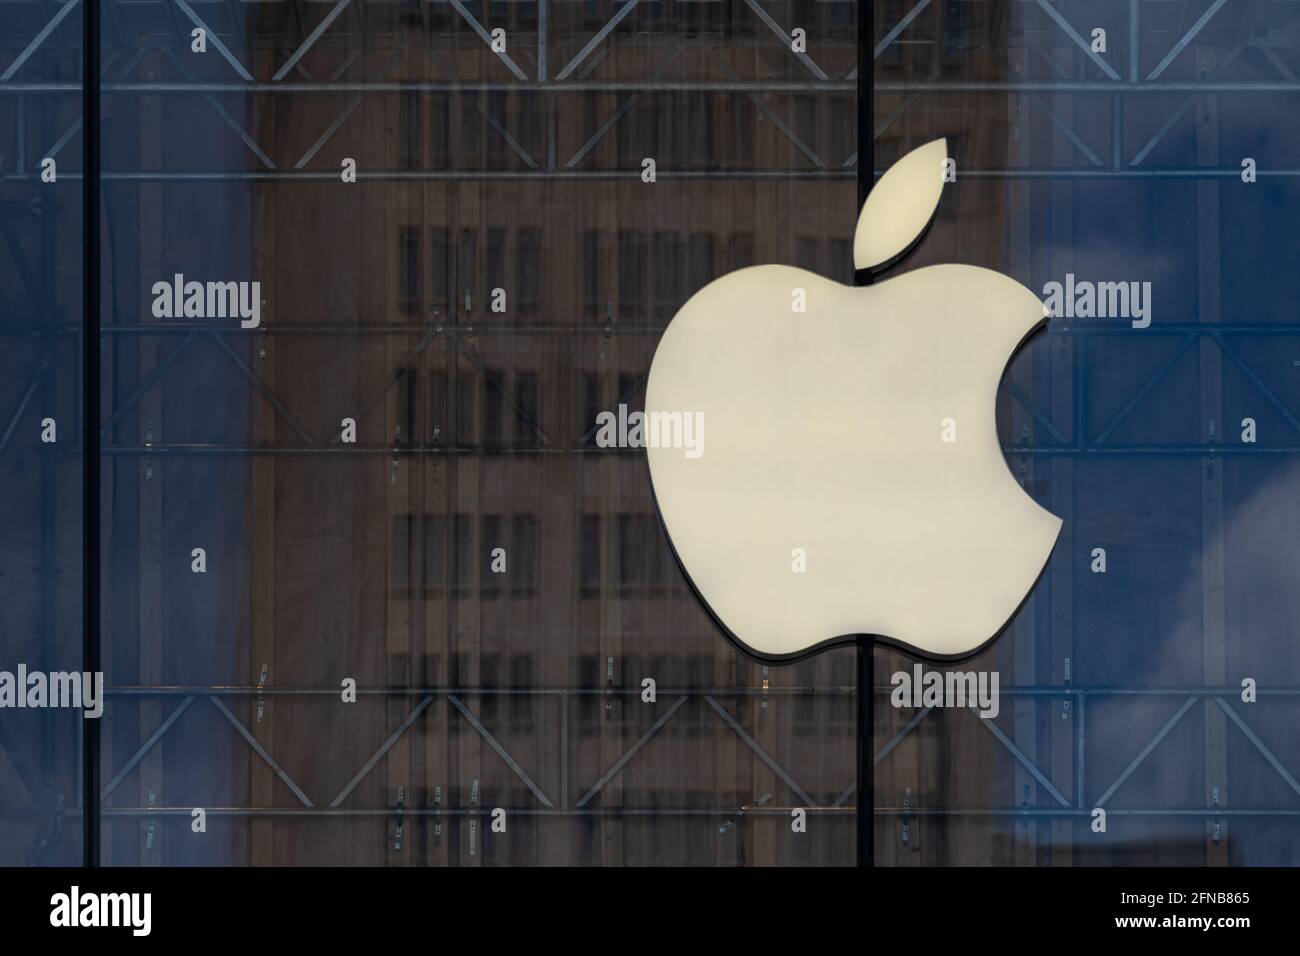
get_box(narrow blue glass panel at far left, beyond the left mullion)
[0,3,85,866]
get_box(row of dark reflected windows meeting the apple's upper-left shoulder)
[397,226,853,319]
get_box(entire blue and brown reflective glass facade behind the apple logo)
[0,0,1300,866]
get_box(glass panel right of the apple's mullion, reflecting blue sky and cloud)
[874,0,1300,865]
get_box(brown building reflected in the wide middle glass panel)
[250,4,857,864]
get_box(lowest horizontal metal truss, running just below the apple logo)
[89,685,1300,821]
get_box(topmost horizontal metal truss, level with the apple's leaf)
[0,0,1300,182]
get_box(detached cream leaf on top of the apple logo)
[853,139,948,274]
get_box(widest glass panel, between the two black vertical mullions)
[89,0,857,865]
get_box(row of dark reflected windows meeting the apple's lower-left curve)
[389,512,680,600]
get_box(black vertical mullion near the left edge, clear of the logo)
[82,0,100,866]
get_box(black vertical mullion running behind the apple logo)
[854,0,876,866]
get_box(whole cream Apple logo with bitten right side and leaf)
[645,139,1061,659]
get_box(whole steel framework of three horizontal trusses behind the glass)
[0,0,1300,868]
